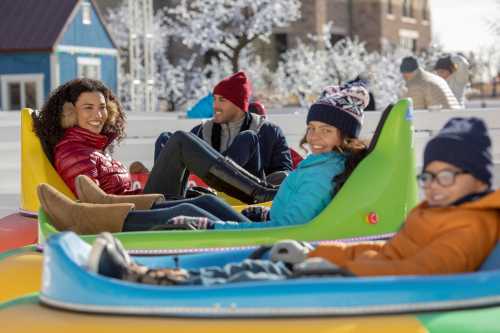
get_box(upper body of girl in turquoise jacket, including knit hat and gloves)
[201,81,368,229]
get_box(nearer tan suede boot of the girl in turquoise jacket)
[37,184,134,235]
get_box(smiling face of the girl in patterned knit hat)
[306,120,342,154]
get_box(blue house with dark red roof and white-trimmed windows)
[0,0,118,111]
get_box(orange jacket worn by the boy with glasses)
[309,191,500,276]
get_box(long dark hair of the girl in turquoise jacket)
[299,129,368,194]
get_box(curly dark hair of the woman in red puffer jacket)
[33,79,125,163]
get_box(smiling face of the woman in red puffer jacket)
[75,92,108,134]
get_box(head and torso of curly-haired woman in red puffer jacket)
[33,79,135,194]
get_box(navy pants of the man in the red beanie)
[154,131,264,178]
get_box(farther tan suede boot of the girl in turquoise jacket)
[75,175,165,210]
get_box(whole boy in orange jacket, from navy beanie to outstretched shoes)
[88,118,500,285]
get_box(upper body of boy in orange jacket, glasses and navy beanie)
[307,118,500,276]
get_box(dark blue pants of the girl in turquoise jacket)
[123,195,250,231]
